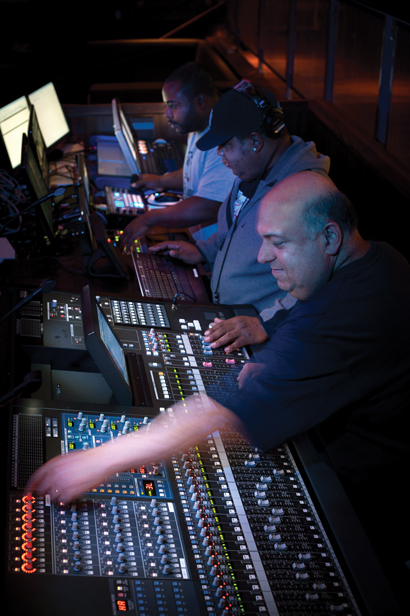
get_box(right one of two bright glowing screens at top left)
[28,82,70,148]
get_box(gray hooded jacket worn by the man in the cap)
[196,136,330,312]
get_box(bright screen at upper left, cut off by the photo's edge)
[0,96,30,169]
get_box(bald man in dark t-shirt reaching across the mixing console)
[28,172,410,612]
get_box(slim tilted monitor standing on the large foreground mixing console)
[81,286,132,406]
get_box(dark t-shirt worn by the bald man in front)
[213,242,410,482]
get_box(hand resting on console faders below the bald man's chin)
[205,316,269,353]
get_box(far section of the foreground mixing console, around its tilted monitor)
[18,293,255,409]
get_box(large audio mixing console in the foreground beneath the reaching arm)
[6,291,395,616]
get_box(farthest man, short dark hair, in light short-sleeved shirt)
[122,62,233,248]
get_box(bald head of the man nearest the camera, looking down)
[257,171,368,300]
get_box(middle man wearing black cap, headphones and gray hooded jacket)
[147,80,330,316]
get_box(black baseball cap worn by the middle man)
[196,80,283,150]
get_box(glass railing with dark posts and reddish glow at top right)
[228,0,410,169]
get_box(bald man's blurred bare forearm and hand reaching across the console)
[26,396,242,503]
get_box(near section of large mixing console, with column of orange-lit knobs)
[6,401,360,616]
